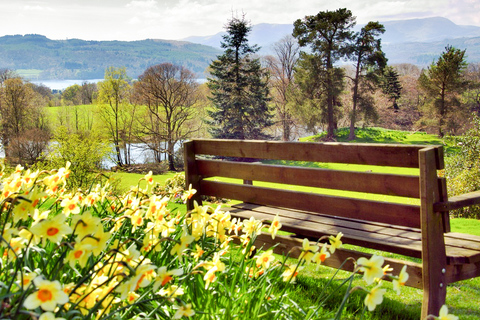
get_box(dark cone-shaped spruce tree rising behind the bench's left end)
[207,17,272,139]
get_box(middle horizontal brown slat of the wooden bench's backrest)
[197,160,419,198]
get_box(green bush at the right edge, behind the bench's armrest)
[445,116,480,219]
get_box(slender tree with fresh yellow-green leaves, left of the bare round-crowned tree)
[98,67,134,166]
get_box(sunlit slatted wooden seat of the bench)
[230,204,480,265]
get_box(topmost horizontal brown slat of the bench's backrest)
[193,139,443,169]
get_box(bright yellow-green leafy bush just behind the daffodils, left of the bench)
[38,126,111,188]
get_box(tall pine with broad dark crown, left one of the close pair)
[293,8,355,139]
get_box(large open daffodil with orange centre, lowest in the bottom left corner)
[23,277,68,311]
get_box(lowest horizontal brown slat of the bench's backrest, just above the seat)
[200,180,420,228]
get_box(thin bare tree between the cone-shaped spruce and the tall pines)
[266,36,300,141]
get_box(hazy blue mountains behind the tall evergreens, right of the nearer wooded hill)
[183,17,480,66]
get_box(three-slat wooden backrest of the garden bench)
[184,140,449,232]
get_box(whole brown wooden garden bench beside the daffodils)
[184,140,480,319]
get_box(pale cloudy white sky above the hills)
[0,0,480,41]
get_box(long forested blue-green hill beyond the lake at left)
[0,34,221,80]
